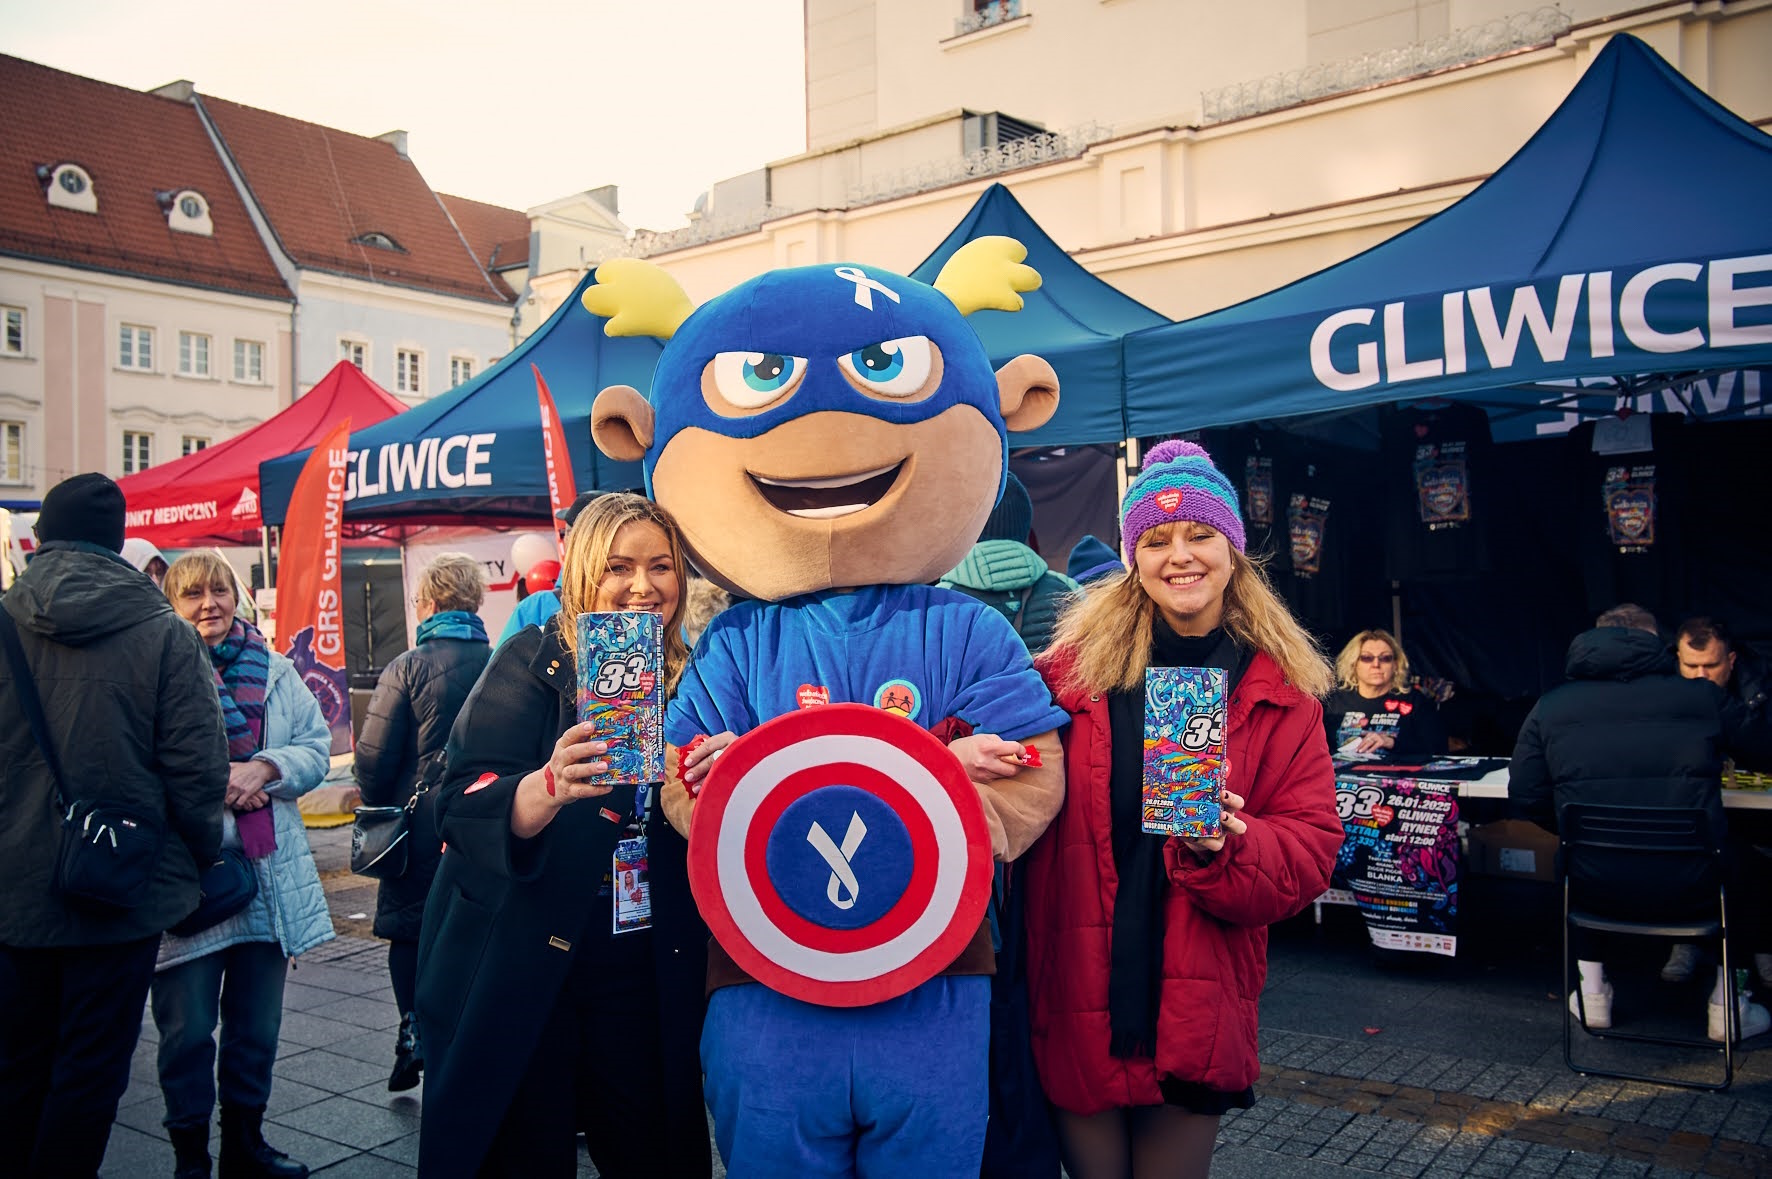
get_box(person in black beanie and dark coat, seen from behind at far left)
[0,473,229,1175]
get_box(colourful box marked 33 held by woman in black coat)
[578,610,665,785]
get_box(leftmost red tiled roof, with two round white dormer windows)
[0,55,291,300]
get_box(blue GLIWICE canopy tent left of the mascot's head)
[259,275,663,534]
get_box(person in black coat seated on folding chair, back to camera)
[1508,603,1772,1041]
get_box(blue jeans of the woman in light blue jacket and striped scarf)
[154,941,289,1126]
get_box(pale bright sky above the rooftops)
[0,0,806,229]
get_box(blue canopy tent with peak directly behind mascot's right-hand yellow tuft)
[911,184,1170,447]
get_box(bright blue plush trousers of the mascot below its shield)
[702,975,991,1179]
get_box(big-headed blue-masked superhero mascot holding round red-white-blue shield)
[585,238,1065,1179]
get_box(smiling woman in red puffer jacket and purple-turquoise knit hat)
[1028,441,1341,1179]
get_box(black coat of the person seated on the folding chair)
[1508,626,1740,910]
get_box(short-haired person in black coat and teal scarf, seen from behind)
[356,553,493,1092]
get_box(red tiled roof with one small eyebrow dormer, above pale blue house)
[198,94,510,303]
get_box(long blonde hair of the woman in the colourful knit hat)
[1053,523,1334,697]
